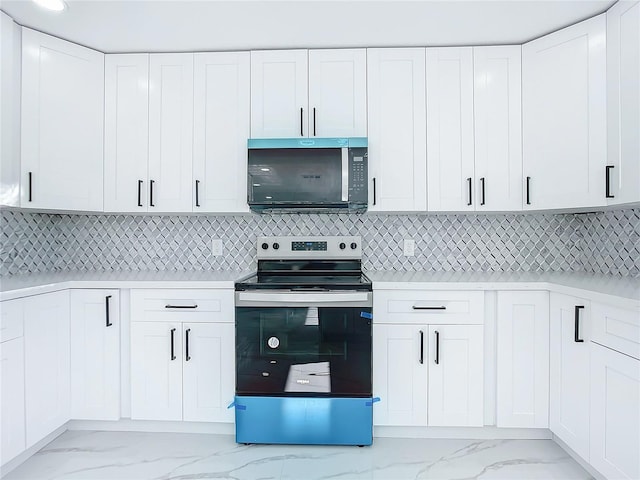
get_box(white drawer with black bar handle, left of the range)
[131,288,234,322]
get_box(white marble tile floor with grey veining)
[4,431,592,480]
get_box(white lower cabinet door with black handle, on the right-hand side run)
[549,293,590,461]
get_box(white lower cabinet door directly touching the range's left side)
[182,323,235,422]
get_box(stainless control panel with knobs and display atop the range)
[257,235,362,260]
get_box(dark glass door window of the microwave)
[249,148,342,203]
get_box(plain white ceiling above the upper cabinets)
[0,0,615,53]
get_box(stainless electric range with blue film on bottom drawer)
[234,236,374,445]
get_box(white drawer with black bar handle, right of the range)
[373,290,484,325]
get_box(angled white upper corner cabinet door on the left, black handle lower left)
[21,28,104,211]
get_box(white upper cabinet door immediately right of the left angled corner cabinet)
[104,54,149,212]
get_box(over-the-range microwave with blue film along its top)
[247,138,368,212]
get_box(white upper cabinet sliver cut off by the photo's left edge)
[0,12,22,207]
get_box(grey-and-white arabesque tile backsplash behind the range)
[0,209,640,277]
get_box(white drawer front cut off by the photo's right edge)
[591,302,640,359]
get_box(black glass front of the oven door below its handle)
[236,307,371,397]
